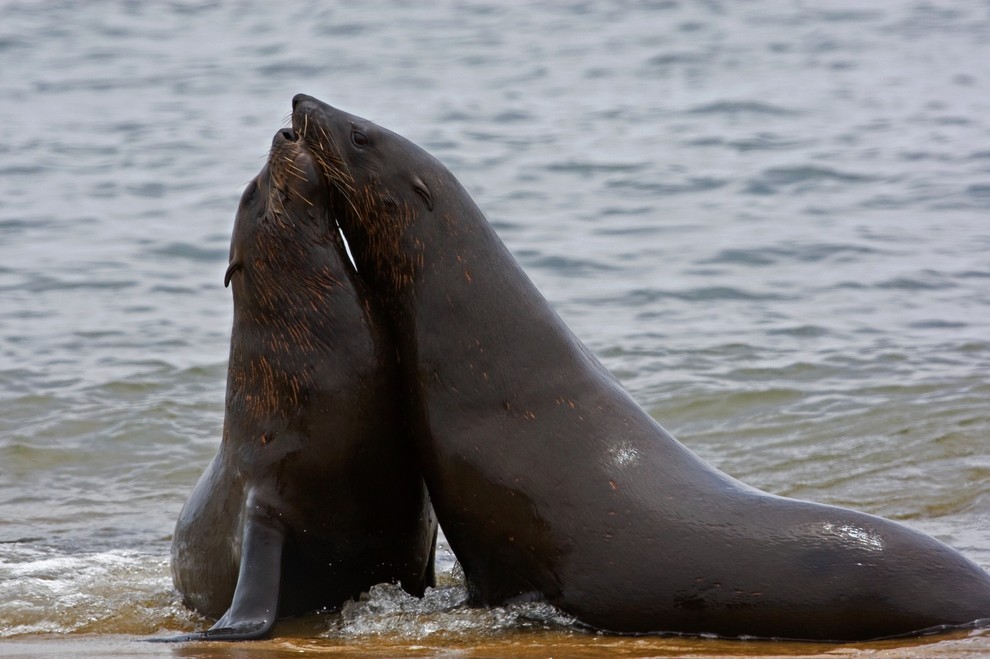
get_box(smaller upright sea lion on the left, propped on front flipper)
[166,130,436,640]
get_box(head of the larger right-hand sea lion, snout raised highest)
[292,94,442,296]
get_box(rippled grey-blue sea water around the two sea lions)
[0,0,990,656]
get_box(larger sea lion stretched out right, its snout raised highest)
[292,95,990,641]
